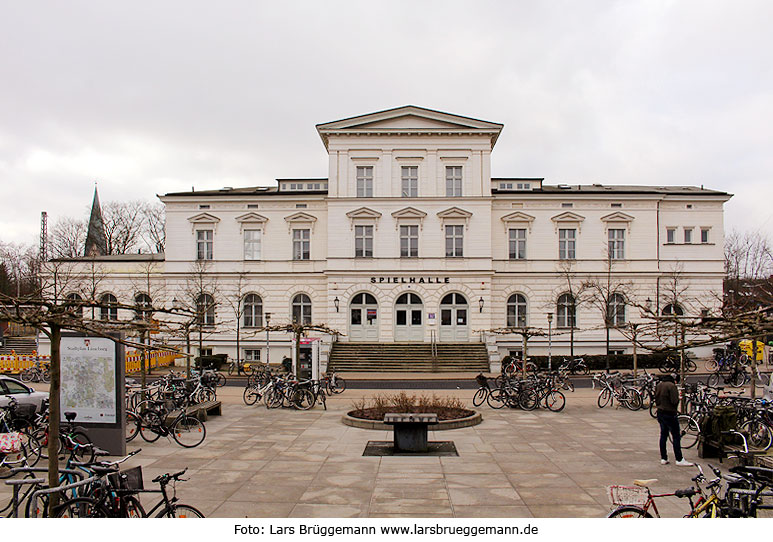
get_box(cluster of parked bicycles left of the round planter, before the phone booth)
[242,369,346,410]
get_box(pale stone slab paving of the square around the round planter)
[0,387,726,517]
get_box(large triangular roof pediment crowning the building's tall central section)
[317,105,503,147]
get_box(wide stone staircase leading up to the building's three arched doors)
[328,342,489,373]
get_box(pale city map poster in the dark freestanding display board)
[61,337,118,423]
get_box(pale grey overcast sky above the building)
[0,0,773,248]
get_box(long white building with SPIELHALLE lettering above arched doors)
[49,106,731,370]
